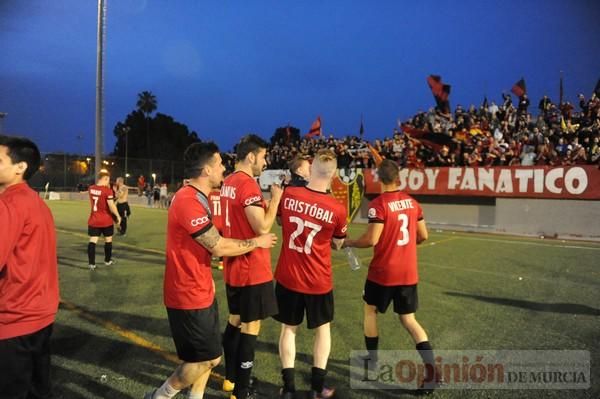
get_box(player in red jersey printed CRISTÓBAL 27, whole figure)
[275,150,347,399]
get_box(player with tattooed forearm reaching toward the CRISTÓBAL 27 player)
[145,143,277,399]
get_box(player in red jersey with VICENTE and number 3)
[344,160,434,390]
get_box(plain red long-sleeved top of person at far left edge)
[0,183,59,340]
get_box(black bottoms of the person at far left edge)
[0,324,53,399]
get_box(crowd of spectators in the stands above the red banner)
[236,90,600,169]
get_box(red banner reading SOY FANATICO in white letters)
[364,165,600,200]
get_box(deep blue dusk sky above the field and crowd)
[0,0,600,153]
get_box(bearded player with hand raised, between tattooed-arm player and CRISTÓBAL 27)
[221,134,282,399]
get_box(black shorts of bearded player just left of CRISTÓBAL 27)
[225,281,277,323]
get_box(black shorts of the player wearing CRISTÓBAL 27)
[273,283,333,328]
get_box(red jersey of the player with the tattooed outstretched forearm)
[163,186,215,309]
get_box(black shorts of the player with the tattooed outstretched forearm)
[167,300,221,363]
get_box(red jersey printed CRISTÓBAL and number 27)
[275,186,348,295]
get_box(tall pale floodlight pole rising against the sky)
[94,0,106,174]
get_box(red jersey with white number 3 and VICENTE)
[367,191,423,286]
